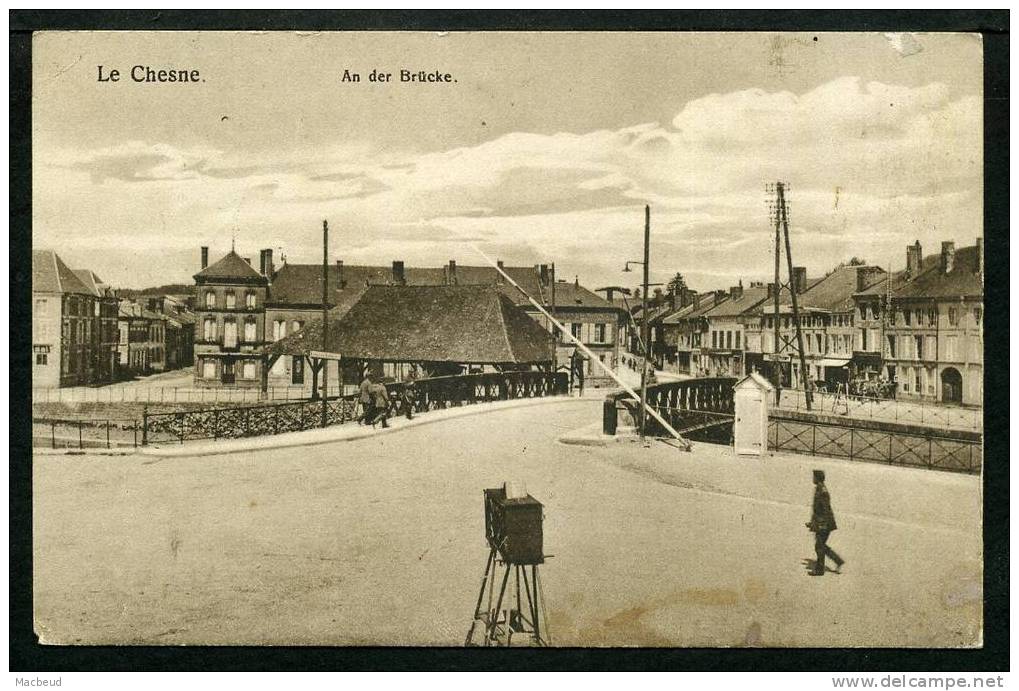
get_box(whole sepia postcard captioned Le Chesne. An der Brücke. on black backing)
[32,31,984,648]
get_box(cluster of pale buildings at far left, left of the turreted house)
[32,250,195,387]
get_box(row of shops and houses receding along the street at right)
[635,238,983,405]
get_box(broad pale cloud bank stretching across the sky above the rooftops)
[34,76,982,287]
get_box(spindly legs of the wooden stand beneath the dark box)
[464,547,552,647]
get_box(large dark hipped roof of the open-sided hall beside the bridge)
[270,285,551,364]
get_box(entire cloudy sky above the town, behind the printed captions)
[33,33,982,289]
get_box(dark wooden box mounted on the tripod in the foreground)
[485,484,545,565]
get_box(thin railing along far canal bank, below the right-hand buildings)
[777,389,983,432]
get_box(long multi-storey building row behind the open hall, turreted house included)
[189,247,629,387]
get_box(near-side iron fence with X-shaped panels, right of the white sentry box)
[768,418,983,473]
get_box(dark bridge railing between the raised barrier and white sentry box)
[602,377,737,436]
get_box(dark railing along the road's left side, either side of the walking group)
[142,371,569,444]
